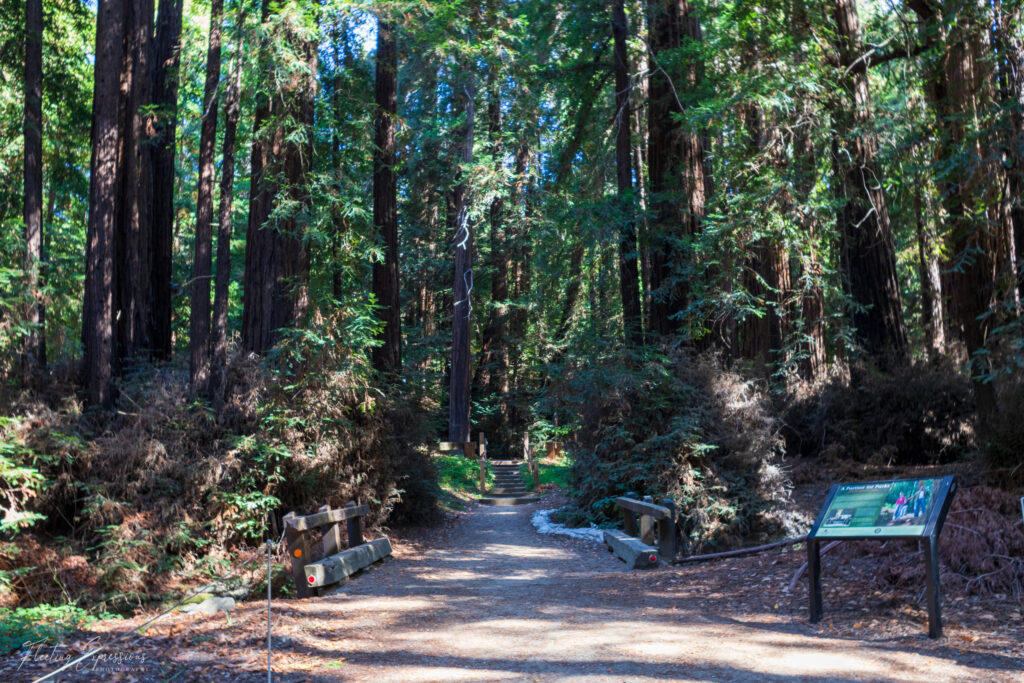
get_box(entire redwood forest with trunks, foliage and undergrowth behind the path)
[0,0,1024,614]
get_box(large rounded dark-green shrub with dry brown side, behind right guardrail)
[555,350,807,552]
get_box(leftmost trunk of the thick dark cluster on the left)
[82,0,124,408]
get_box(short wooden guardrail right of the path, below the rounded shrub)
[604,496,676,569]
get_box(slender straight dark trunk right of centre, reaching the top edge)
[611,0,643,346]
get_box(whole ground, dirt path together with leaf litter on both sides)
[0,495,1024,683]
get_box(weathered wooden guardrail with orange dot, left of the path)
[284,501,391,598]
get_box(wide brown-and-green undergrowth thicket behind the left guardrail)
[0,325,436,609]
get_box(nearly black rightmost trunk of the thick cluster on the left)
[148,0,182,360]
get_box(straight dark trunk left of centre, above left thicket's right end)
[372,17,401,373]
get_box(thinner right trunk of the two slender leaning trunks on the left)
[210,21,245,407]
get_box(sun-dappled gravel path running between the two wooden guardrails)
[282,505,1024,682]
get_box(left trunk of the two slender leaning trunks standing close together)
[188,0,224,394]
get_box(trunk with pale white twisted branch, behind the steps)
[449,74,474,441]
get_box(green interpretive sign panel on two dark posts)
[807,476,956,638]
